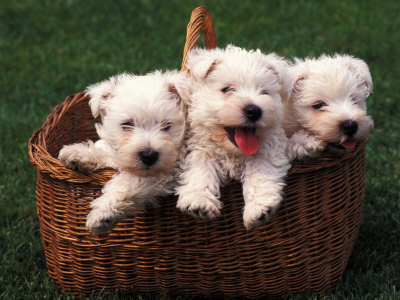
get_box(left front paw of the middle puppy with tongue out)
[176,193,222,219]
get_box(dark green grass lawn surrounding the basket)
[0,0,400,299]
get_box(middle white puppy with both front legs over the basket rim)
[177,46,290,229]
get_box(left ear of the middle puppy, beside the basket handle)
[186,48,219,79]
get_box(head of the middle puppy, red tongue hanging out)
[187,45,287,155]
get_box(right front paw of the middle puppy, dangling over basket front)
[243,203,274,230]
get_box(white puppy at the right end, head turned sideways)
[283,54,373,159]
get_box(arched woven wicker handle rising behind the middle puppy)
[181,6,217,71]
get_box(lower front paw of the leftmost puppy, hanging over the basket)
[86,208,121,235]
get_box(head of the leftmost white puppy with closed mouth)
[87,71,187,177]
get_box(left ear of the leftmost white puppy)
[86,77,117,118]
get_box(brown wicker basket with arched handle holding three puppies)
[29,7,365,298]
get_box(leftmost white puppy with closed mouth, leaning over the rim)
[59,72,187,234]
